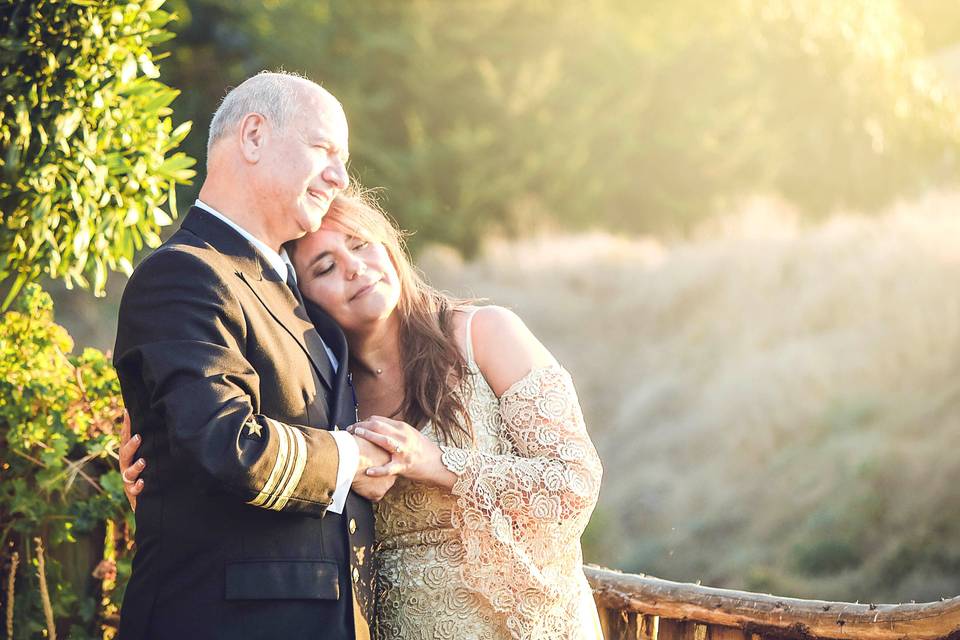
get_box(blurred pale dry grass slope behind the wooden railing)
[421,193,960,601]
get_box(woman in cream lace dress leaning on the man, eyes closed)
[121,192,601,639]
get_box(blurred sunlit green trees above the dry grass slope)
[158,0,960,253]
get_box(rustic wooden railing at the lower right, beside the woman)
[584,566,960,640]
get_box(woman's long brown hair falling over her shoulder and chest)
[308,186,473,444]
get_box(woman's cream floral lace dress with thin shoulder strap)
[374,315,602,640]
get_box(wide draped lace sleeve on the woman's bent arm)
[441,366,602,638]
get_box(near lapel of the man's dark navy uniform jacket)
[182,207,334,389]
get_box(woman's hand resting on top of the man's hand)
[348,416,457,489]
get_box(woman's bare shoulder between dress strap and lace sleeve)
[454,305,557,396]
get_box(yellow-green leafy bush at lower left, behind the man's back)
[0,283,130,638]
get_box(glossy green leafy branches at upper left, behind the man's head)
[0,0,194,308]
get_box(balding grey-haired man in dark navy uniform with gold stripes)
[114,73,392,640]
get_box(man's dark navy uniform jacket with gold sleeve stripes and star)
[114,208,374,640]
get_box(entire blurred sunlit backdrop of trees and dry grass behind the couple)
[45,0,960,602]
